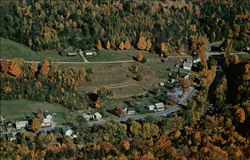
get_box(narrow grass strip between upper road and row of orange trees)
[86,49,157,62]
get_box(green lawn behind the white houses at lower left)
[1,100,68,120]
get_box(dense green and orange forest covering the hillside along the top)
[0,0,250,54]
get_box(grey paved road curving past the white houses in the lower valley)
[88,87,196,126]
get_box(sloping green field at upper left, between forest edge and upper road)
[0,37,83,62]
